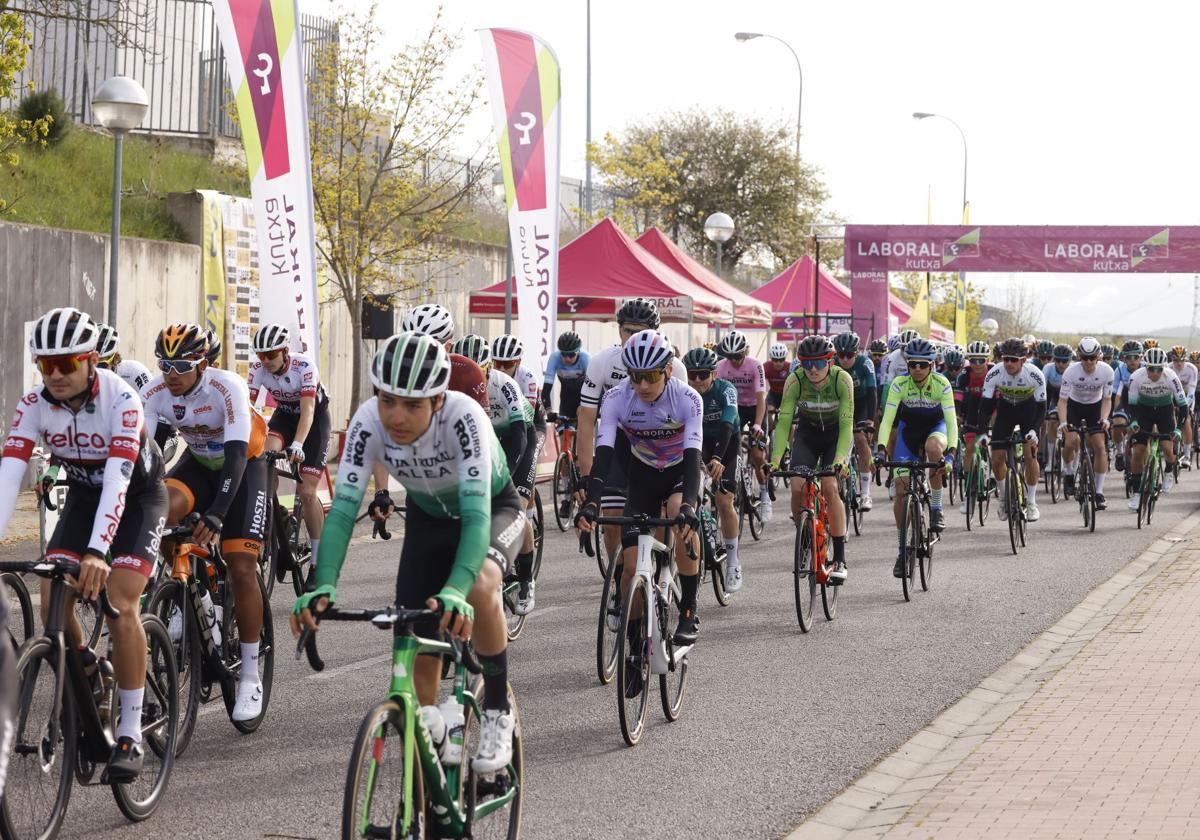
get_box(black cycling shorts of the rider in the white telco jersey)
[46,465,169,578]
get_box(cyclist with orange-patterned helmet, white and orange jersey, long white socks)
[145,324,266,721]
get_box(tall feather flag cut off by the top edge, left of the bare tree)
[212,0,319,355]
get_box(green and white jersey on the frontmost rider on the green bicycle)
[317,391,509,592]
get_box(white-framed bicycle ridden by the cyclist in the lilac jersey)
[595,514,695,746]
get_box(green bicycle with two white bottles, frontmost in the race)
[296,606,524,840]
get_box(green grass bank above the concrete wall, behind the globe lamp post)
[0,126,250,241]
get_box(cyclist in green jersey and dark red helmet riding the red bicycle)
[770,336,854,586]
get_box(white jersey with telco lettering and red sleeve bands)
[0,370,151,557]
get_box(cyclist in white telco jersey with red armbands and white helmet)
[0,307,167,784]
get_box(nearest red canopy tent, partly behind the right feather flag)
[469,218,731,323]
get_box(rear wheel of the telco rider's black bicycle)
[112,616,180,822]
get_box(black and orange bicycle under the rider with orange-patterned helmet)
[144,514,275,755]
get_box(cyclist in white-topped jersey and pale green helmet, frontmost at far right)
[1128,347,1187,510]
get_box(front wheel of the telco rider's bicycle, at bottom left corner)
[0,637,79,840]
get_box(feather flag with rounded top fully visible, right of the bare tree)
[480,29,562,382]
